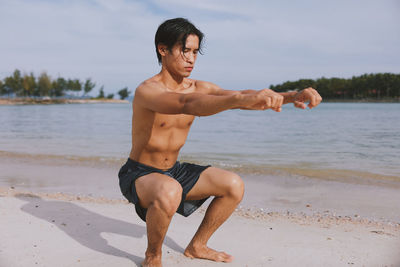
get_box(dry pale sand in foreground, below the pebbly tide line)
[0,190,400,267]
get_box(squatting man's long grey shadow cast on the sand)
[15,194,184,266]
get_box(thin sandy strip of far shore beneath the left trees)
[0,98,129,105]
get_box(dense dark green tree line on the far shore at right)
[270,73,400,100]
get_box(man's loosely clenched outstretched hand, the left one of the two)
[242,89,284,112]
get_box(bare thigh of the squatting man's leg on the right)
[186,167,243,200]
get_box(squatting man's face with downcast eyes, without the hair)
[163,34,199,77]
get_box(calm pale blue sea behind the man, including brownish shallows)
[0,103,400,181]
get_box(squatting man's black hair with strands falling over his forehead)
[154,18,204,64]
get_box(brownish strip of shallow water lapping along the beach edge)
[0,150,400,189]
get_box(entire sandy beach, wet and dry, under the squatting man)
[0,153,400,267]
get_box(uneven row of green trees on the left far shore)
[0,69,130,99]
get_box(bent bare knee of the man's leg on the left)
[150,181,182,216]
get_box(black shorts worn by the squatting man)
[118,158,210,221]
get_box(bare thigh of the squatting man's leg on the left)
[135,173,182,209]
